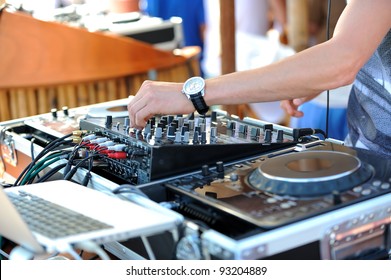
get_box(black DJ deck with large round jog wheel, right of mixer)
[161,142,391,229]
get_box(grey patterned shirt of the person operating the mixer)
[348,29,391,156]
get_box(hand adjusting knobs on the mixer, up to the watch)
[128,81,194,129]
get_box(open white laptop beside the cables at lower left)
[0,180,178,254]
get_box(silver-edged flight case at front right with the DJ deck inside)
[107,141,391,259]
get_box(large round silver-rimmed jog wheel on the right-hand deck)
[247,151,373,197]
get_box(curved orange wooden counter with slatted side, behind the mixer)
[0,11,200,121]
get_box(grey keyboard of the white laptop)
[7,191,112,239]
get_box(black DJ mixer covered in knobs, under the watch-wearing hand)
[80,110,312,184]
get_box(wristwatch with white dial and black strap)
[182,77,209,115]
